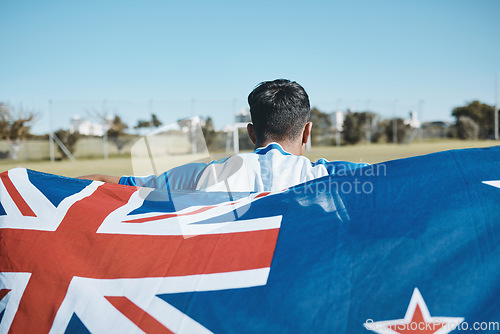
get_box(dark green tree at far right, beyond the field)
[452,100,495,139]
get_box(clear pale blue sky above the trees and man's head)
[0,0,500,133]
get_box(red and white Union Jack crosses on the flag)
[0,169,281,333]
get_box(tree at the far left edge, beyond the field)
[0,102,36,160]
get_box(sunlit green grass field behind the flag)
[0,140,499,177]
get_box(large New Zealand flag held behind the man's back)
[0,147,500,334]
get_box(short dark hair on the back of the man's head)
[248,79,311,141]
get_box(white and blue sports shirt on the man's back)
[120,143,368,192]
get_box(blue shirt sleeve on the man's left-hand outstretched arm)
[119,162,207,190]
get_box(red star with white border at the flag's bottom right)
[363,288,464,334]
